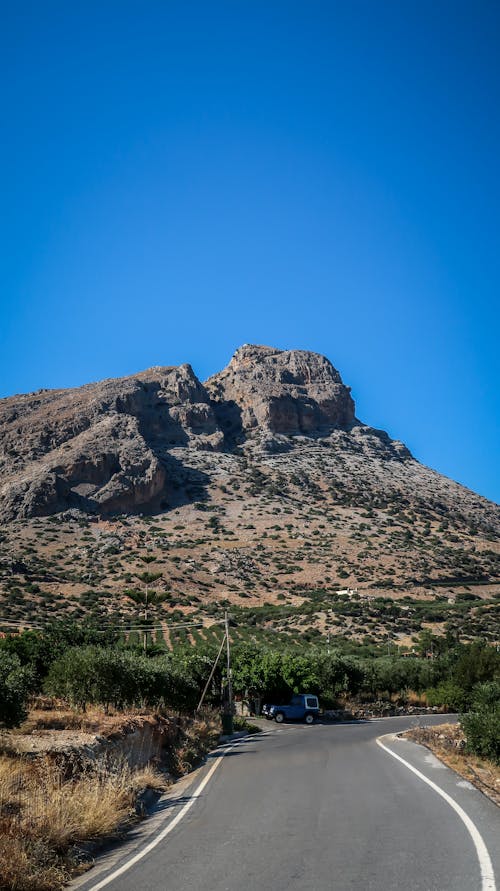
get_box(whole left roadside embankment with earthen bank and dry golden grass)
[0,708,220,891]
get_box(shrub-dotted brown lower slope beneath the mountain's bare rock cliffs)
[0,452,500,650]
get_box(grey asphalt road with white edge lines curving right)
[74,717,500,891]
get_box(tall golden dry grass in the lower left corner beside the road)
[0,756,168,891]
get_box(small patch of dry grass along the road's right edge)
[404,724,500,805]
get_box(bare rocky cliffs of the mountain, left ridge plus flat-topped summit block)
[0,346,370,518]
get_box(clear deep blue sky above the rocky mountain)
[0,0,500,500]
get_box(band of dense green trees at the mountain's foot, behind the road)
[0,623,500,758]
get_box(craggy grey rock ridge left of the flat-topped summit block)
[0,365,224,518]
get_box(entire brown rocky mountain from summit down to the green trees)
[0,345,500,646]
